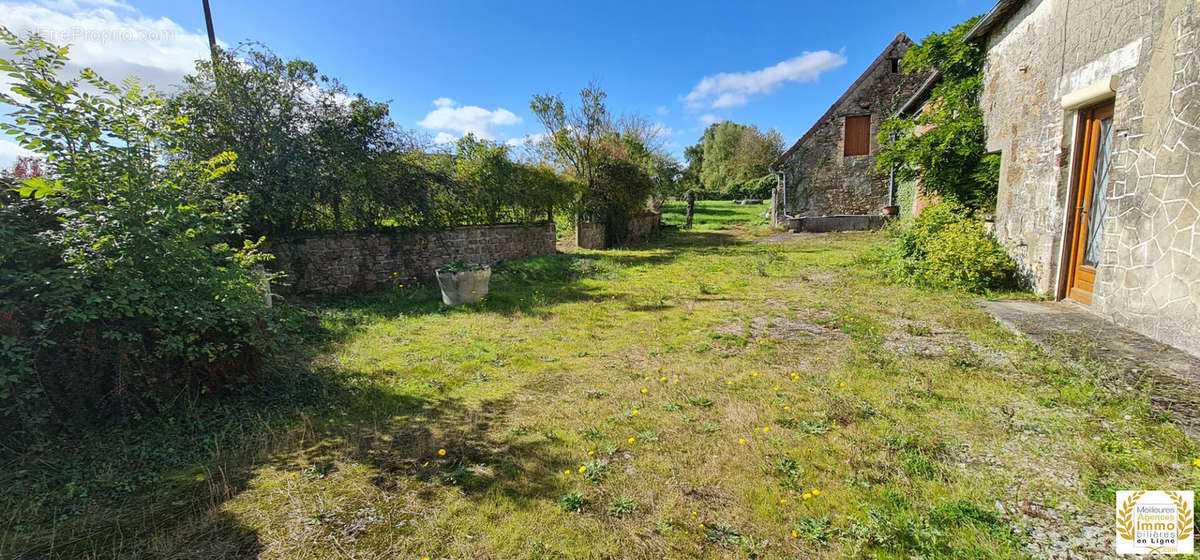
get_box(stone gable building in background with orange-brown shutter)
[770,34,928,229]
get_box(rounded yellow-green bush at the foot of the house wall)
[887,201,1016,293]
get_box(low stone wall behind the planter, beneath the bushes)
[268,222,556,293]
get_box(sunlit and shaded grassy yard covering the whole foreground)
[0,203,1200,559]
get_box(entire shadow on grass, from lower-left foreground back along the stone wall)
[0,225,748,558]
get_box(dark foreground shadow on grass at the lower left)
[0,359,580,559]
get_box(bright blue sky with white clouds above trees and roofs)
[0,0,992,164]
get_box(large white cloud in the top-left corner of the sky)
[0,0,216,88]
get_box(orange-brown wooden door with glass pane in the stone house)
[1067,102,1112,303]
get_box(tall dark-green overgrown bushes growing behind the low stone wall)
[168,44,574,236]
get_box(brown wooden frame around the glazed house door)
[1055,97,1116,306]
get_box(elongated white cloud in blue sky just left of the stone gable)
[683,50,846,109]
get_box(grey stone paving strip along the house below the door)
[979,301,1200,441]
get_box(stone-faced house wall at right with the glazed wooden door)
[966,0,1200,355]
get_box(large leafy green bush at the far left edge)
[0,29,281,444]
